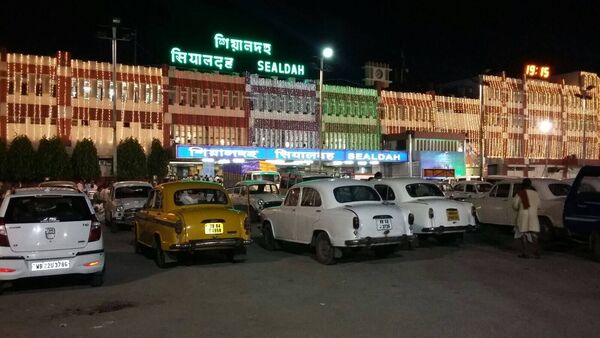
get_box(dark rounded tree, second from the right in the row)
[117,137,147,180]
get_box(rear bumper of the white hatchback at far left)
[0,250,104,281]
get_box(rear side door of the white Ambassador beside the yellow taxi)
[294,187,323,243]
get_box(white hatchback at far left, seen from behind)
[0,188,104,292]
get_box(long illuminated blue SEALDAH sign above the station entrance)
[176,145,408,162]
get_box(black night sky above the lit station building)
[0,0,600,90]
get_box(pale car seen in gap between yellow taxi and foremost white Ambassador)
[227,180,283,222]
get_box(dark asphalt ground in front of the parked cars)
[0,224,600,337]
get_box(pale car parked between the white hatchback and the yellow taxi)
[104,181,152,232]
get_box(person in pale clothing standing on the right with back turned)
[512,178,540,258]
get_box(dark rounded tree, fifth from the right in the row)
[6,135,36,182]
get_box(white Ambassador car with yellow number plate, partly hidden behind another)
[369,177,477,241]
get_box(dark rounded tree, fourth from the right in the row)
[37,136,72,180]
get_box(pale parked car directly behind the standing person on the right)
[469,178,570,241]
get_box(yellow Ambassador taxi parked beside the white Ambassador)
[134,182,252,268]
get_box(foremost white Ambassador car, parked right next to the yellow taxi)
[262,179,413,264]
